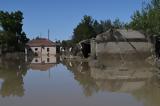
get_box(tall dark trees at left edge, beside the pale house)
[0,11,29,52]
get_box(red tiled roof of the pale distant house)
[26,38,56,47]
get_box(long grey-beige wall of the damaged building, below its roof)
[96,42,152,54]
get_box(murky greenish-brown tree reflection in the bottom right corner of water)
[131,78,160,106]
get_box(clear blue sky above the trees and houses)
[0,0,148,40]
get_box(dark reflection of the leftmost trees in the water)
[0,58,27,97]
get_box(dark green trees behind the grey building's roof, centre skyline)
[72,15,126,43]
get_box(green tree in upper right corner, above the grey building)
[130,0,160,35]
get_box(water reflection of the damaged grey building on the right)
[90,55,154,92]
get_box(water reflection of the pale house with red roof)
[29,55,59,71]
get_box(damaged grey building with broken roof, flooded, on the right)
[91,29,152,56]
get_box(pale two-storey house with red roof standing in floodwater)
[25,38,56,56]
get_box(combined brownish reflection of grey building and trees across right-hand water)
[63,55,160,106]
